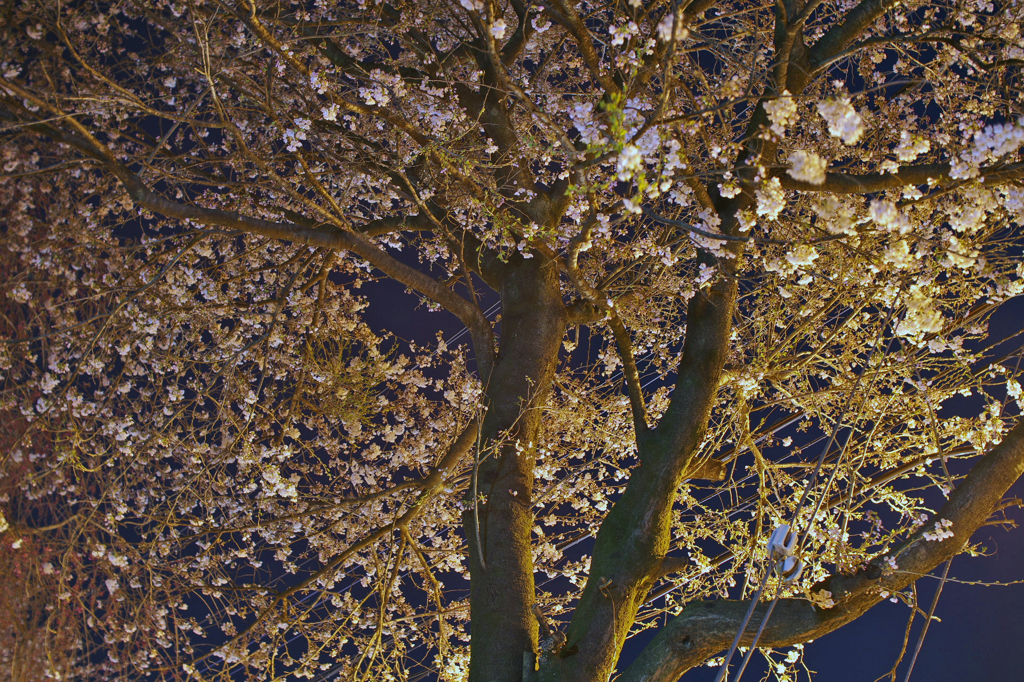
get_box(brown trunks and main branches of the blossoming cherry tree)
[0,0,1024,682]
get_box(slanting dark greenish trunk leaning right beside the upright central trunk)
[541,280,736,681]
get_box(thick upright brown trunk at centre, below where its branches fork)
[464,257,566,682]
